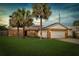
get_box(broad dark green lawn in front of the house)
[0,37,79,56]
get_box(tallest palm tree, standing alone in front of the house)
[32,3,51,39]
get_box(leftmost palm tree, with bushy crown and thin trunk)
[10,9,20,37]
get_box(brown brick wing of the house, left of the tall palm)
[8,26,40,37]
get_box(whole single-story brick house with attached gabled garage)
[9,23,72,38]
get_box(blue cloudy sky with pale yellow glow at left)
[0,3,79,26]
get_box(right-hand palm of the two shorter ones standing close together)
[21,9,33,38]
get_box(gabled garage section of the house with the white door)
[38,23,72,38]
